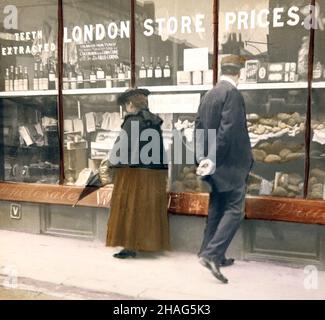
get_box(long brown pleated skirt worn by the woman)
[106,168,169,251]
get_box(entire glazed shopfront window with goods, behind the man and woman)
[0,0,325,205]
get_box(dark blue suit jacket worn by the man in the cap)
[195,81,253,192]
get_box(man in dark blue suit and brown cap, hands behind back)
[196,55,253,283]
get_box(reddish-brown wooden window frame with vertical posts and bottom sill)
[0,0,325,224]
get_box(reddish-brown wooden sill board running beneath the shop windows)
[0,183,325,224]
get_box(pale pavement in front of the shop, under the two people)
[0,231,325,300]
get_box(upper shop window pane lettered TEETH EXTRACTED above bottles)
[0,0,58,94]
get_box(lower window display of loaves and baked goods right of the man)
[243,90,306,198]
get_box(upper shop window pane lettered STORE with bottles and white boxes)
[135,0,213,87]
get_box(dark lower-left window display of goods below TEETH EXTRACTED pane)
[3,97,60,184]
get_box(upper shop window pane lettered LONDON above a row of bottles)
[63,0,131,90]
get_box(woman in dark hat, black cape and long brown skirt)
[106,89,169,258]
